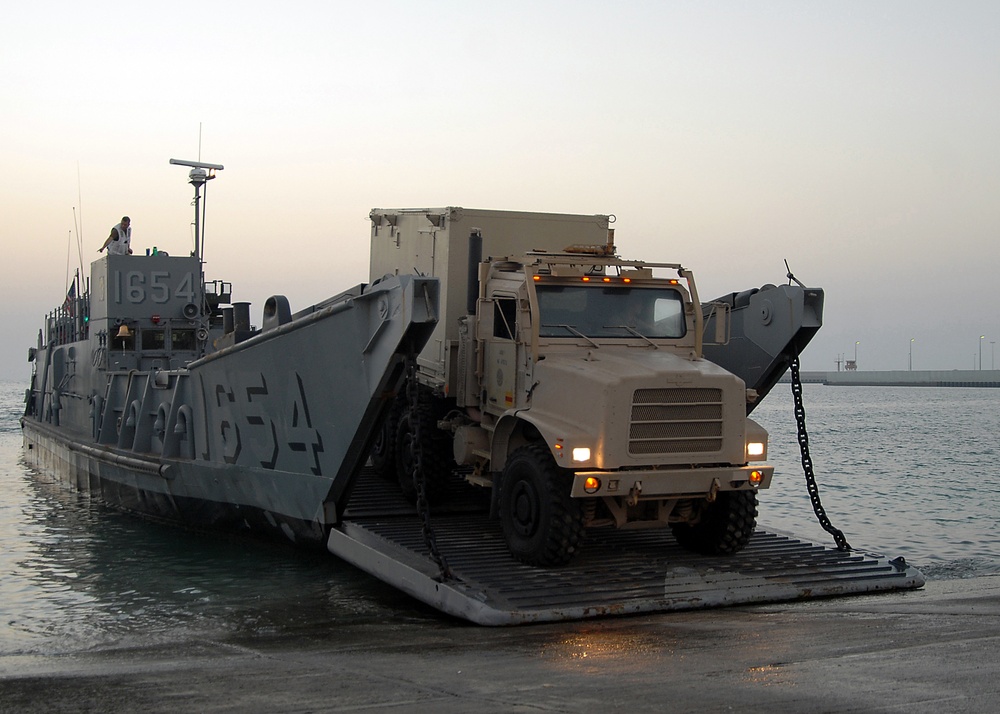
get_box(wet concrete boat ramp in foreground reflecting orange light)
[0,577,1000,712]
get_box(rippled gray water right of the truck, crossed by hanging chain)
[753,384,1000,578]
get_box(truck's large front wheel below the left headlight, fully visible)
[499,444,584,566]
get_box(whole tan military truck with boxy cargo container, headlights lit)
[370,207,773,566]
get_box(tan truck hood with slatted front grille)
[519,346,746,469]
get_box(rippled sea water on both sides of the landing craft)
[0,382,1000,657]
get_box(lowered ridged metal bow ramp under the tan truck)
[328,478,924,625]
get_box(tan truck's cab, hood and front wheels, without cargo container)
[455,251,773,564]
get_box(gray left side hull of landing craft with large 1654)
[22,276,437,544]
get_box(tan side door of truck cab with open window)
[483,295,522,413]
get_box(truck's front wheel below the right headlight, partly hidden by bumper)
[670,491,757,555]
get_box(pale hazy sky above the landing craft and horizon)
[0,0,1000,380]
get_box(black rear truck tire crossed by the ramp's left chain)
[393,389,455,501]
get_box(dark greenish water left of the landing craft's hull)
[0,394,435,655]
